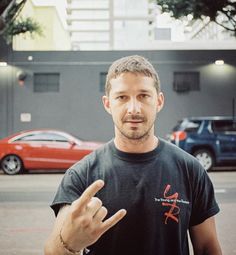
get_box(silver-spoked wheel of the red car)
[1,155,24,175]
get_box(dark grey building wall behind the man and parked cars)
[0,50,236,141]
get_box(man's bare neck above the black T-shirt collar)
[114,134,158,153]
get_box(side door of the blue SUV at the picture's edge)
[212,120,236,161]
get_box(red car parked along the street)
[0,129,102,175]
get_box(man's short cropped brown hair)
[105,55,161,95]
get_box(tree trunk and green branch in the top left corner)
[0,0,42,44]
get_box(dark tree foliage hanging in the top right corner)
[156,0,236,37]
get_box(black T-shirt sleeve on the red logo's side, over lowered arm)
[190,170,220,226]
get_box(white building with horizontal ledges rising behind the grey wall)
[67,0,155,50]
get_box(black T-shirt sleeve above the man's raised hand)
[50,163,86,215]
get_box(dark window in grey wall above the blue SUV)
[173,72,200,93]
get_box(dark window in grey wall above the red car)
[34,73,60,92]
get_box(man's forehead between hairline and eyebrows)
[110,72,156,93]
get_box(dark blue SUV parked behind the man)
[169,117,236,170]
